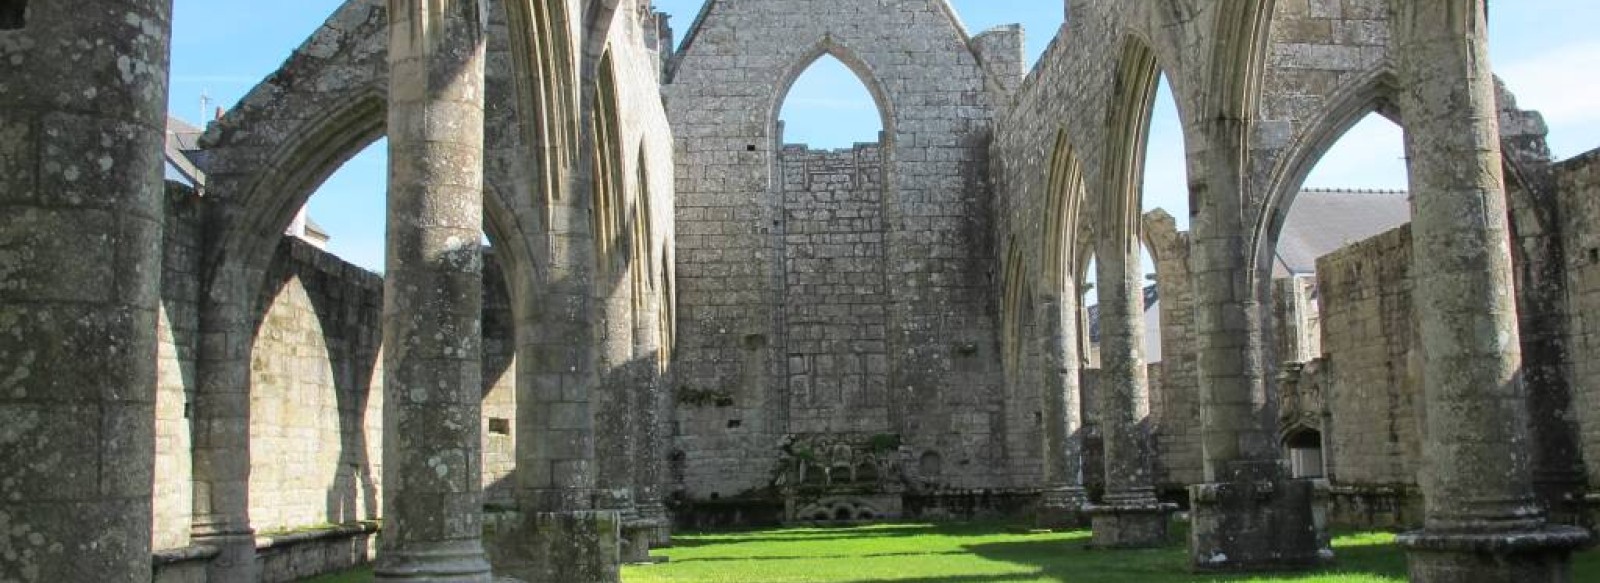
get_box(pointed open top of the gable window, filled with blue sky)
[778,54,883,149]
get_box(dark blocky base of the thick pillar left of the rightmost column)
[1189,474,1333,572]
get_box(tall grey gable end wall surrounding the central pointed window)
[664,0,1010,500]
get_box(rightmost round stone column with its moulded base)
[1390,0,1589,583]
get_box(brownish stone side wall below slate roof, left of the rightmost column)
[1317,227,1422,485]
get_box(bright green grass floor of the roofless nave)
[300,524,1600,583]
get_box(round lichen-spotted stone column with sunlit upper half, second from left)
[376,0,490,581]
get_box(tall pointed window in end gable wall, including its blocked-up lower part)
[777,49,902,434]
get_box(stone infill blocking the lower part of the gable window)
[779,144,891,434]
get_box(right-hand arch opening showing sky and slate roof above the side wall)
[1270,114,1411,364]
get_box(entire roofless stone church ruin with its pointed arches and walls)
[0,0,1600,583]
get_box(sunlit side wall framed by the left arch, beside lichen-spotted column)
[250,237,382,532]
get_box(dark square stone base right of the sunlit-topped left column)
[483,509,622,583]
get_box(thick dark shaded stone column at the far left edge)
[0,0,171,583]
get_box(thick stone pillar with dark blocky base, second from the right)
[1189,114,1333,570]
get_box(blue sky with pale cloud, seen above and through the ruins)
[170,0,1600,271]
